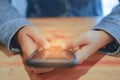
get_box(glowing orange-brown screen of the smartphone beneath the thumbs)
[33,46,74,60]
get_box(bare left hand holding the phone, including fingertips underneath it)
[17,26,53,73]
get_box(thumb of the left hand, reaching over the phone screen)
[28,29,49,48]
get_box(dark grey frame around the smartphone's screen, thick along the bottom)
[25,46,78,68]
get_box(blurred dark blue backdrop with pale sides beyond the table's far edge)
[11,0,119,17]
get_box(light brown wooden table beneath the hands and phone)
[0,18,120,80]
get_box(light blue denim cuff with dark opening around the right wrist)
[93,20,120,55]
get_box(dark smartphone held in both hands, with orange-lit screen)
[25,46,78,68]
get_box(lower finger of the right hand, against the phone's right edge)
[76,45,97,63]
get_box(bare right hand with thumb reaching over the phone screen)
[62,30,113,63]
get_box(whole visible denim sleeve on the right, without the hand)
[93,4,120,55]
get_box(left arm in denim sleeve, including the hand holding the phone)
[0,0,53,73]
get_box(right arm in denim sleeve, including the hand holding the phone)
[62,4,120,63]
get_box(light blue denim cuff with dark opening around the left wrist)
[1,18,32,52]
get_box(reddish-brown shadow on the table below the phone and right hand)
[25,53,104,80]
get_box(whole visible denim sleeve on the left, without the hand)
[0,0,31,51]
